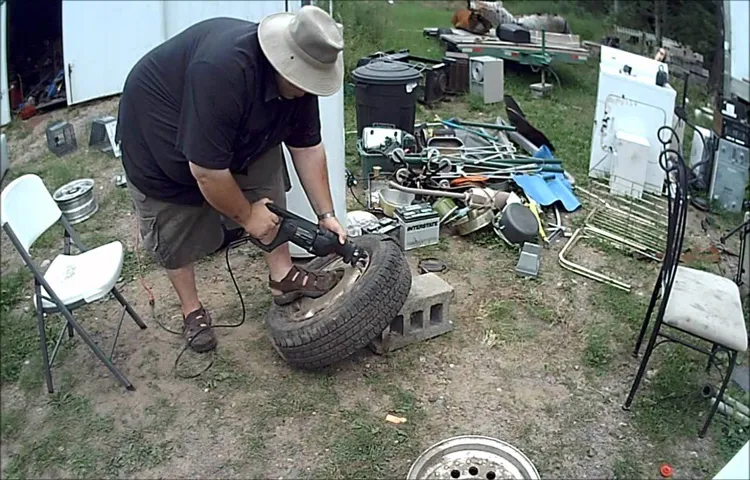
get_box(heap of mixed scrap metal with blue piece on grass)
[347,97,580,276]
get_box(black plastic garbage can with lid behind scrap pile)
[352,60,422,137]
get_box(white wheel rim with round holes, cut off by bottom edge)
[407,435,539,480]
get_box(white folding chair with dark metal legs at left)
[0,175,146,393]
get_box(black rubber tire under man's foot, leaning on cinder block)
[266,235,411,370]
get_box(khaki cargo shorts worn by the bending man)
[128,145,291,270]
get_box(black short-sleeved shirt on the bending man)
[117,18,321,205]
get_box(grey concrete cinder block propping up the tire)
[370,273,454,355]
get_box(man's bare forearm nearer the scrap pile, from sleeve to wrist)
[288,142,333,215]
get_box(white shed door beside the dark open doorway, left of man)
[62,0,166,105]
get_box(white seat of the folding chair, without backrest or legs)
[34,241,124,308]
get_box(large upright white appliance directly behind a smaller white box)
[589,63,676,194]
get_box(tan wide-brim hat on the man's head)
[258,5,344,97]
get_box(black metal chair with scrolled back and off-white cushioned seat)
[623,127,748,438]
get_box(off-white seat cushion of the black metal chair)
[664,266,747,352]
